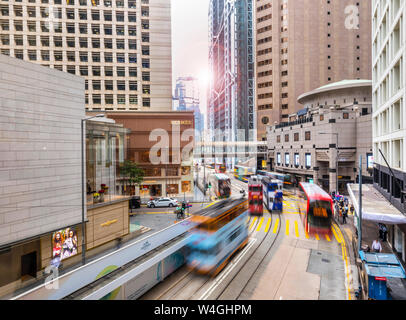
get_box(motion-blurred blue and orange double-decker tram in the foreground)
[186,199,248,276]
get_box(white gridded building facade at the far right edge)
[371,0,406,261]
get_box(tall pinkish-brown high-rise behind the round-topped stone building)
[255,0,371,140]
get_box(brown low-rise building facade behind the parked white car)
[100,111,195,202]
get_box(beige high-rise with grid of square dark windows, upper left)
[0,0,172,111]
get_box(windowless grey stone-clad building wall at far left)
[0,55,85,295]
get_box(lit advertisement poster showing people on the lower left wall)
[52,228,78,262]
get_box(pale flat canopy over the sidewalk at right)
[347,184,406,224]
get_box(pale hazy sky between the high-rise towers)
[171,0,209,113]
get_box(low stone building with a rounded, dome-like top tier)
[268,80,372,192]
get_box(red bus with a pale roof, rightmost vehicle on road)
[297,182,334,236]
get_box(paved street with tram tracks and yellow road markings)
[142,178,349,300]
